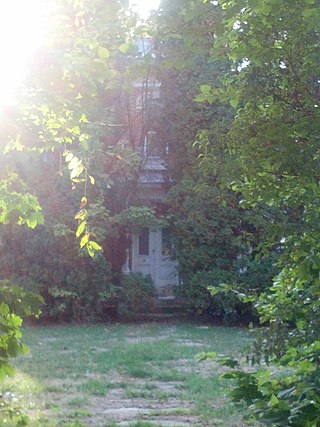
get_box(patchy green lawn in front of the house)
[0,324,254,427]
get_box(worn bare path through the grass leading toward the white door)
[77,336,234,427]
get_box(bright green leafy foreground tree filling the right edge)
[196,0,320,426]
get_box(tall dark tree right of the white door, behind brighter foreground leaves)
[152,0,275,324]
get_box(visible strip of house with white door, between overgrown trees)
[123,40,179,296]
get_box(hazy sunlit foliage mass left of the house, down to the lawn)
[0,0,162,328]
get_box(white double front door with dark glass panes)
[132,227,178,292]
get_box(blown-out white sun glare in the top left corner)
[0,0,53,105]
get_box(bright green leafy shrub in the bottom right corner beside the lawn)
[201,341,319,427]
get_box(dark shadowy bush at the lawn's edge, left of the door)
[0,226,116,322]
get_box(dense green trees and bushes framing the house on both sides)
[0,0,320,427]
